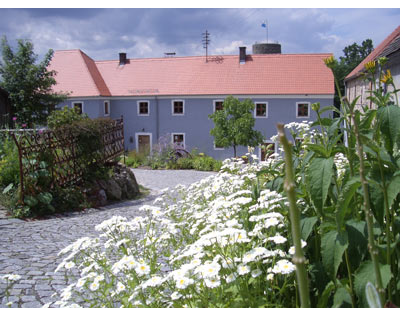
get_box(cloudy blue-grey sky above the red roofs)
[0,8,400,60]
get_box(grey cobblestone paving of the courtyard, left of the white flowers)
[0,169,215,308]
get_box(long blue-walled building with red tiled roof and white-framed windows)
[49,44,334,159]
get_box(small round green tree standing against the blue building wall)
[209,96,264,157]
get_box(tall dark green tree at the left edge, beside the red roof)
[0,36,67,127]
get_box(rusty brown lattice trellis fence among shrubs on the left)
[9,117,125,201]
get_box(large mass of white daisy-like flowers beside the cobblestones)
[46,151,312,307]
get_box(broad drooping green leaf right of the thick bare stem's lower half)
[321,230,349,280]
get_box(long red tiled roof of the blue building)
[50,50,334,97]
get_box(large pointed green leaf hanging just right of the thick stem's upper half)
[307,157,334,213]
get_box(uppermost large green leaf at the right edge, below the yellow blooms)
[377,105,400,152]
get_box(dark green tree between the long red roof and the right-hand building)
[332,39,374,108]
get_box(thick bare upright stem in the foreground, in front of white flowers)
[277,124,310,308]
